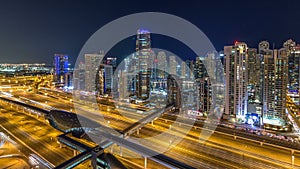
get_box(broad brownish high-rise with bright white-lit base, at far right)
[263,48,288,126]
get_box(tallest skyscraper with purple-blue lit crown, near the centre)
[136,29,151,100]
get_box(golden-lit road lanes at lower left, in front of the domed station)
[0,103,91,167]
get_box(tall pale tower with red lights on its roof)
[223,42,248,120]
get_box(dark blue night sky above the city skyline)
[0,0,300,64]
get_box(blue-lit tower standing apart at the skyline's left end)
[54,54,69,86]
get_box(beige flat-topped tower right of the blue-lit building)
[84,52,104,92]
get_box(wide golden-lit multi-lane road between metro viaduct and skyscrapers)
[4,91,300,168]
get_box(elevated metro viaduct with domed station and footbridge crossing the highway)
[1,94,197,168]
